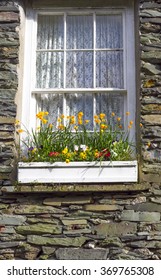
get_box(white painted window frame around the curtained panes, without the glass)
[21,1,136,142]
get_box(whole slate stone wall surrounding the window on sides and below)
[0,0,161,259]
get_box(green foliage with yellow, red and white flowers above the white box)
[16,112,134,163]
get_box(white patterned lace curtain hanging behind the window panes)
[36,13,124,129]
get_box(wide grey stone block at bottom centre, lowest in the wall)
[55,248,109,260]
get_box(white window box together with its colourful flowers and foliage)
[16,111,137,183]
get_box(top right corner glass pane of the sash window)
[96,15,123,49]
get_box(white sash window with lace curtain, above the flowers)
[22,1,135,140]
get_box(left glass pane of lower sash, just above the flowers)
[37,93,63,126]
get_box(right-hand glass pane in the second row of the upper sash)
[96,51,124,89]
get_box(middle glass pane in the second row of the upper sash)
[66,51,93,88]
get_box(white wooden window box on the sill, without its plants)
[18,160,138,183]
